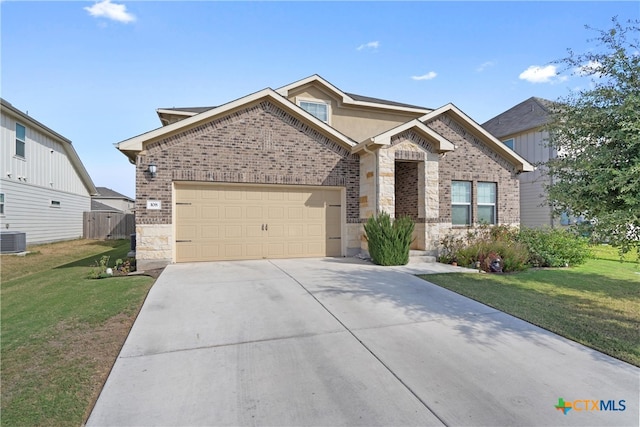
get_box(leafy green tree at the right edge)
[547,18,640,256]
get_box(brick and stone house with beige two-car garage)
[117,75,533,268]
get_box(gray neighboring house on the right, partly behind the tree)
[482,97,566,227]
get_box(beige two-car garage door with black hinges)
[175,183,342,262]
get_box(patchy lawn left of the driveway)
[0,240,153,426]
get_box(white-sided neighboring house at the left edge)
[0,99,96,244]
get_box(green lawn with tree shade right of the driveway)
[421,246,640,366]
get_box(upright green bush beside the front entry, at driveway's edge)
[364,212,415,265]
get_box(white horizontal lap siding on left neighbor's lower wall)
[0,179,91,244]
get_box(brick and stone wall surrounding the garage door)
[136,101,360,268]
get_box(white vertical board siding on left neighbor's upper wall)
[0,112,89,196]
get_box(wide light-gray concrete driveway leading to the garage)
[88,258,640,426]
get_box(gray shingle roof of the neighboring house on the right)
[482,96,554,138]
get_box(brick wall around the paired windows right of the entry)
[427,116,520,225]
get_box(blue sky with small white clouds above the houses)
[0,0,640,197]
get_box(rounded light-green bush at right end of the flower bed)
[517,228,591,267]
